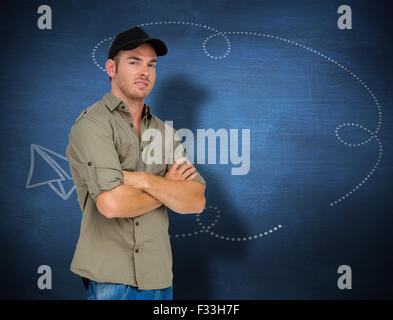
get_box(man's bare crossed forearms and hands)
[97,158,206,218]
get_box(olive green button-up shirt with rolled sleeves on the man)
[66,93,206,290]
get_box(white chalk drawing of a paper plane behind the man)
[26,144,75,200]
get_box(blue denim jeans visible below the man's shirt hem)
[87,280,173,300]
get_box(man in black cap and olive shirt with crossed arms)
[66,27,206,300]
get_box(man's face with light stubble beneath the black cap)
[108,43,157,99]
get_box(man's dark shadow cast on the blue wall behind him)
[151,74,247,299]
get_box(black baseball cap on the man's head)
[108,27,168,59]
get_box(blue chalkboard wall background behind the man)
[0,0,393,299]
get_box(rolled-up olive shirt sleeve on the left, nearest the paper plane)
[66,117,124,202]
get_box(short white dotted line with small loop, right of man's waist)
[169,205,282,241]
